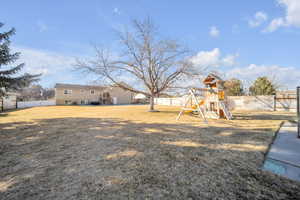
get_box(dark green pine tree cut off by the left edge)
[0,22,40,97]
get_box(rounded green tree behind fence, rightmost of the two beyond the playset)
[249,76,276,95]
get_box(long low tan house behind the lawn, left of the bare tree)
[55,83,134,105]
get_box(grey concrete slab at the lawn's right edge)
[263,122,300,181]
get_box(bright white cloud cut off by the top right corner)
[264,0,300,32]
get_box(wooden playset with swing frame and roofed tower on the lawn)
[176,74,232,122]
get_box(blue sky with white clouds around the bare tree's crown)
[0,0,300,89]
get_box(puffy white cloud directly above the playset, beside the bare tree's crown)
[191,48,238,68]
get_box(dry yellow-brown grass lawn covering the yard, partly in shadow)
[0,106,300,200]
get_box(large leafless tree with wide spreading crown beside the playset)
[75,19,193,111]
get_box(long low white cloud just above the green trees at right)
[226,64,300,89]
